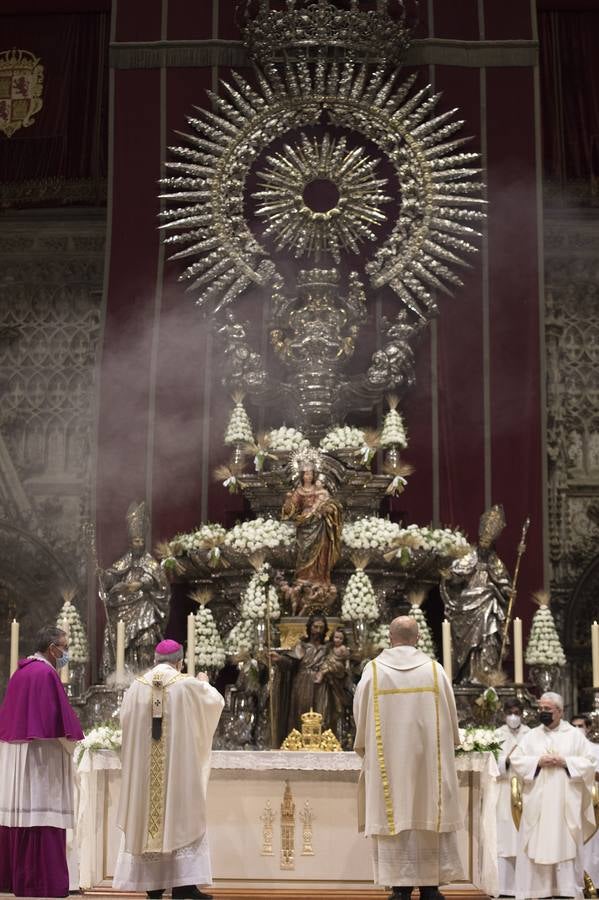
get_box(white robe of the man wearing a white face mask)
[496,725,530,897]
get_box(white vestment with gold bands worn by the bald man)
[354,646,463,836]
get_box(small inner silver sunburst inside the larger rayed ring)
[253,134,391,262]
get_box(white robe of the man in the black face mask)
[510,722,595,900]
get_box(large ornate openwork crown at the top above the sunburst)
[237,0,413,65]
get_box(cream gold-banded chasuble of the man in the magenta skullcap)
[117,663,224,856]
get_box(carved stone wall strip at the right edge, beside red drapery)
[545,211,599,708]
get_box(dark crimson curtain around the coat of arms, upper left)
[0,10,110,206]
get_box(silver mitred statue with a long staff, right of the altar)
[441,506,512,684]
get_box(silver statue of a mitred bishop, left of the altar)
[101,503,169,678]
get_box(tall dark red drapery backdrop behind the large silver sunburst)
[96,0,544,648]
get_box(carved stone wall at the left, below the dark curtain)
[0,210,105,691]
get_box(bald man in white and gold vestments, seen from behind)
[354,616,464,900]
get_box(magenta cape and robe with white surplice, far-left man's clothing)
[0,655,83,897]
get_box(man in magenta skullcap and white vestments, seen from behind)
[113,640,224,900]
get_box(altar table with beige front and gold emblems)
[77,750,498,895]
